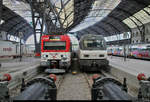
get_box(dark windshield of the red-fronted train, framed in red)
[43,41,66,50]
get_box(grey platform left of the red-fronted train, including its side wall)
[0,57,40,88]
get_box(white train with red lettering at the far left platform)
[0,40,34,59]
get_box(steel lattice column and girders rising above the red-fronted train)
[29,0,72,52]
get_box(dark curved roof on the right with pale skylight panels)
[77,0,150,36]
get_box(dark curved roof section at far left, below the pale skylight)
[1,5,33,40]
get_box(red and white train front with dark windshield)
[41,35,72,72]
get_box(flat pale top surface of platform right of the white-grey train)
[108,56,150,76]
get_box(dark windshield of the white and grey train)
[83,39,106,50]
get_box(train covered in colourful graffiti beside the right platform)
[107,44,150,59]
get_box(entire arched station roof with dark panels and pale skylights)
[1,0,150,40]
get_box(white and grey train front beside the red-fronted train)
[78,34,109,71]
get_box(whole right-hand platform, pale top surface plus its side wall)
[108,56,150,96]
